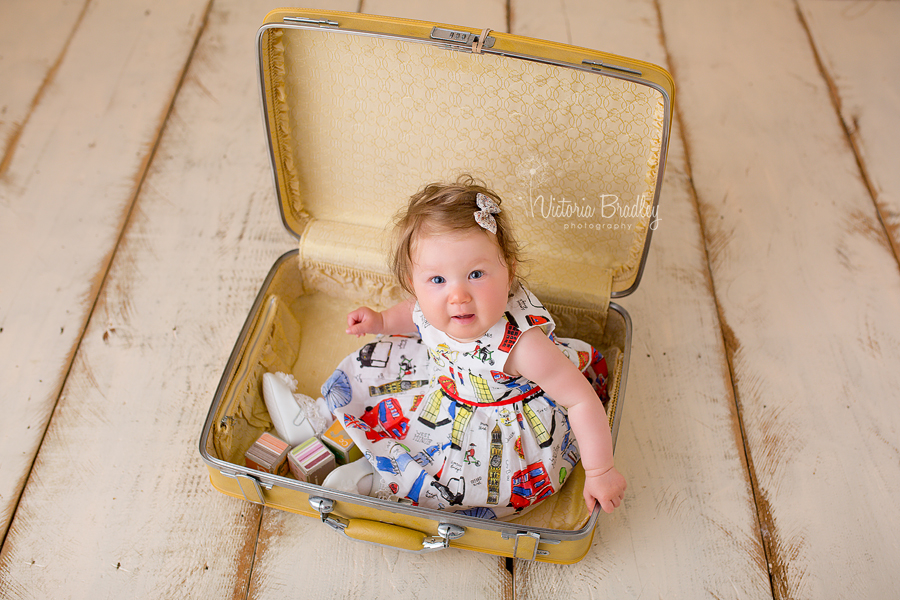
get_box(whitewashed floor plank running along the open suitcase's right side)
[512,0,771,598]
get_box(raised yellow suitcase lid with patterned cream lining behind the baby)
[257,9,674,308]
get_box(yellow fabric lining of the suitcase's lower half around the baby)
[206,255,626,530]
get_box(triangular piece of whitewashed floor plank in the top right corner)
[798,0,900,257]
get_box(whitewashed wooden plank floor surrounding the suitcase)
[0,0,900,599]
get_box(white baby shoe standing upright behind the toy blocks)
[262,373,334,446]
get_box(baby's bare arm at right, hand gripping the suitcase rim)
[506,328,626,513]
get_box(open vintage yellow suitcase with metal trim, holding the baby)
[200,9,674,563]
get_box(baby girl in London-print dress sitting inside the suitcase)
[322,176,626,518]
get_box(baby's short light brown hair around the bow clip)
[391,175,521,294]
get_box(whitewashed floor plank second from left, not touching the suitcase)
[0,0,208,533]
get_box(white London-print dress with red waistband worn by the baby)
[322,285,607,518]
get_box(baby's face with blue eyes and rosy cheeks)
[412,229,511,342]
